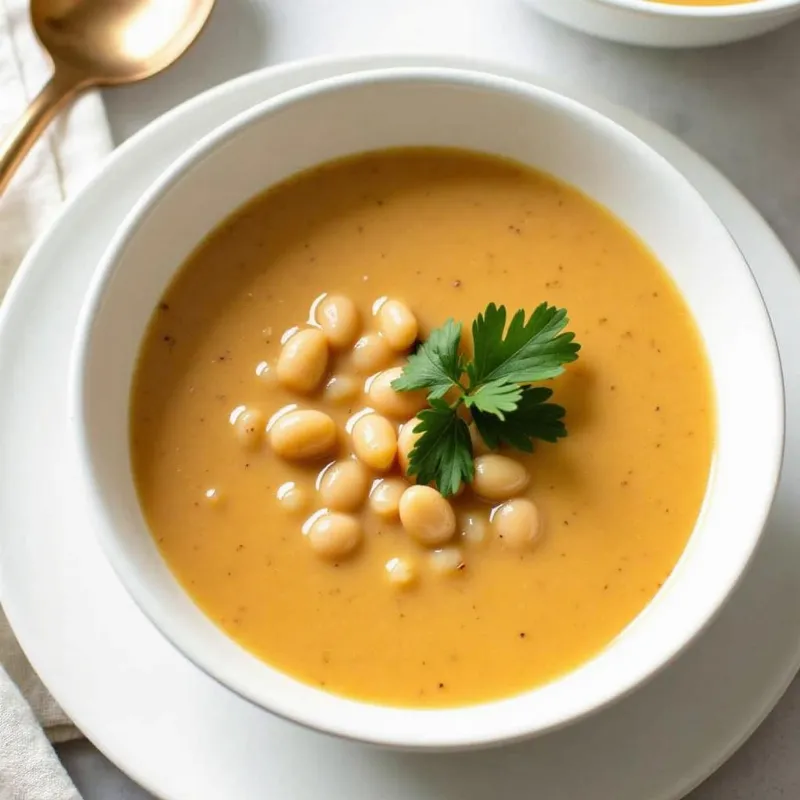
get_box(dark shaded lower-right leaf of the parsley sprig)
[472,386,567,453]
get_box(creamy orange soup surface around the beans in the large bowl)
[131,149,713,706]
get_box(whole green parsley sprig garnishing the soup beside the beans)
[392,303,580,497]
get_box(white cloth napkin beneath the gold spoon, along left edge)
[0,0,112,800]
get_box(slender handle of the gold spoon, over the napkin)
[0,70,84,195]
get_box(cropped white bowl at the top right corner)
[526,0,800,47]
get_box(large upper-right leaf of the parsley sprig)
[467,303,580,388]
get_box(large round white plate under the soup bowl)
[0,51,800,800]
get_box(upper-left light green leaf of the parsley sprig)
[392,319,464,400]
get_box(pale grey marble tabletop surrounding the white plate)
[59,0,800,800]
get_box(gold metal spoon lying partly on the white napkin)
[0,0,215,194]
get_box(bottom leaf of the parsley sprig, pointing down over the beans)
[408,399,474,497]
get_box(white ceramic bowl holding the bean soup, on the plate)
[70,69,783,749]
